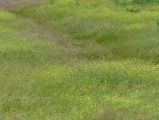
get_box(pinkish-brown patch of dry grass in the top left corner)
[0,0,44,10]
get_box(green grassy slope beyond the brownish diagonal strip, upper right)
[14,0,159,62]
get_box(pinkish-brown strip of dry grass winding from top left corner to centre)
[0,0,87,62]
